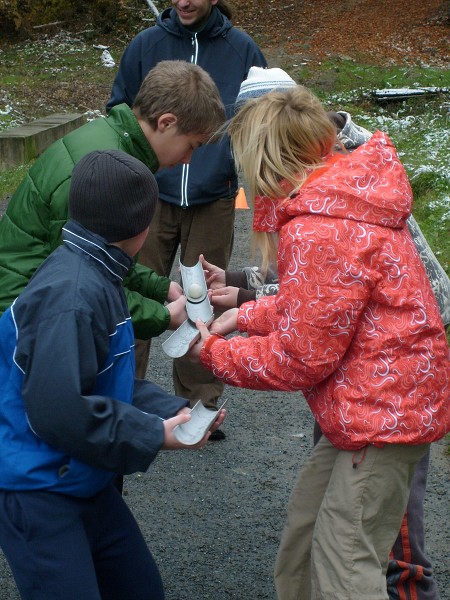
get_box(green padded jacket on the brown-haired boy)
[0,104,170,339]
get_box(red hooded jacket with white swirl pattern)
[201,132,450,450]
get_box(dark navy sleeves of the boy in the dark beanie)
[17,311,179,474]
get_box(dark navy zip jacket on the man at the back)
[106,6,267,208]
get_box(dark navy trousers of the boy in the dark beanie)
[0,485,164,600]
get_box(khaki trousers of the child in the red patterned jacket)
[275,436,429,600]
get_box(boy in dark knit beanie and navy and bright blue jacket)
[0,150,224,600]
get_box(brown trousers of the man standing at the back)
[136,197,235,408]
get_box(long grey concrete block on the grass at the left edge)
[0,113,87,172]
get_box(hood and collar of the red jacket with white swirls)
[253,131,413,232]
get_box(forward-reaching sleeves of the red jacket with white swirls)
[201,220,371,391]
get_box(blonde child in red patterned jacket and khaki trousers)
[191,86,450,600]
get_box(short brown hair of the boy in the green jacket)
[133,60,226,135]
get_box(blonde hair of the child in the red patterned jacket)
[228,85,336,271]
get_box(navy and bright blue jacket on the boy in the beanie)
[0,220,188,497]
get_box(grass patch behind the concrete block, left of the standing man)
[0,31,129,130]
